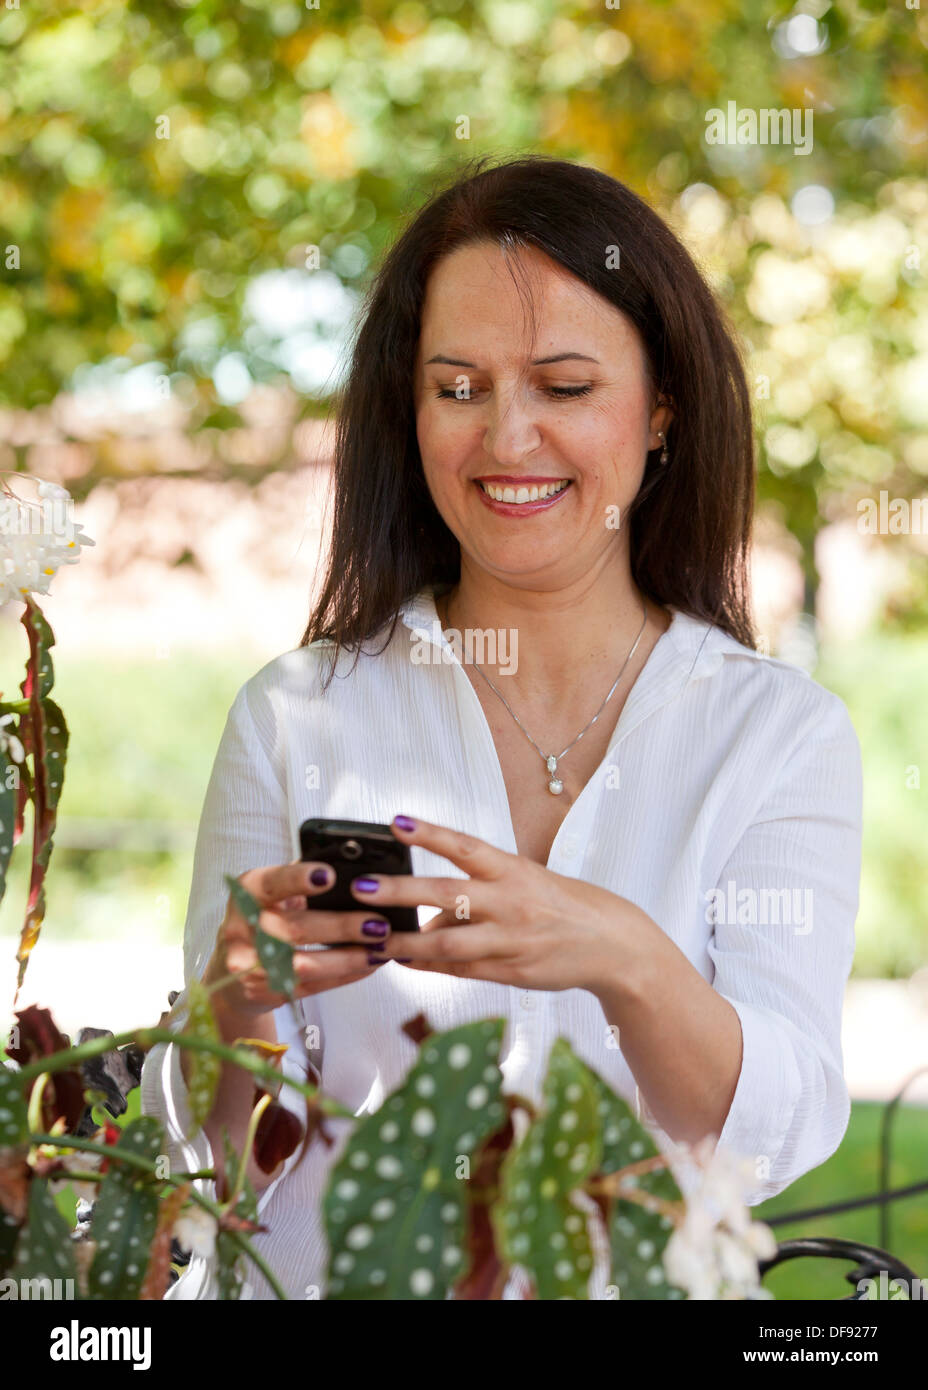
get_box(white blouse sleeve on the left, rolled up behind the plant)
[142,673,321,1228]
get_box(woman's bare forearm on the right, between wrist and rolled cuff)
[593,908,742,1144]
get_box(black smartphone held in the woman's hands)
[300,820,420,949]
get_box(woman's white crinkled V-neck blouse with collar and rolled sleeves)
[142,589,861,1298]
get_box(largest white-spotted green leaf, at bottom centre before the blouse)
[324,1019,506,1300]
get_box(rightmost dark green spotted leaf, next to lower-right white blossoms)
[589,1072,686,1301]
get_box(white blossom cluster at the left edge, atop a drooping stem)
[0,474,94,607]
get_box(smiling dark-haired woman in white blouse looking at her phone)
[143,157,861,1297]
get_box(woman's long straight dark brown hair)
[300,156,754,672]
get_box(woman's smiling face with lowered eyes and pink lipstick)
[414,242,671,589]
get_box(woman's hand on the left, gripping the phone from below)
[204,860,390,1015]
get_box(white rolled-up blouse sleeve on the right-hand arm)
[709,687,863,1205]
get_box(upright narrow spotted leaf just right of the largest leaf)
[493,1038,602,1300]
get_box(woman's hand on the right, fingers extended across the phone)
[351,816,652,992]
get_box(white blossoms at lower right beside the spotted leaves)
[664,1138,777,1300]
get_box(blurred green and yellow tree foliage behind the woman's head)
[0,0,928,609]
